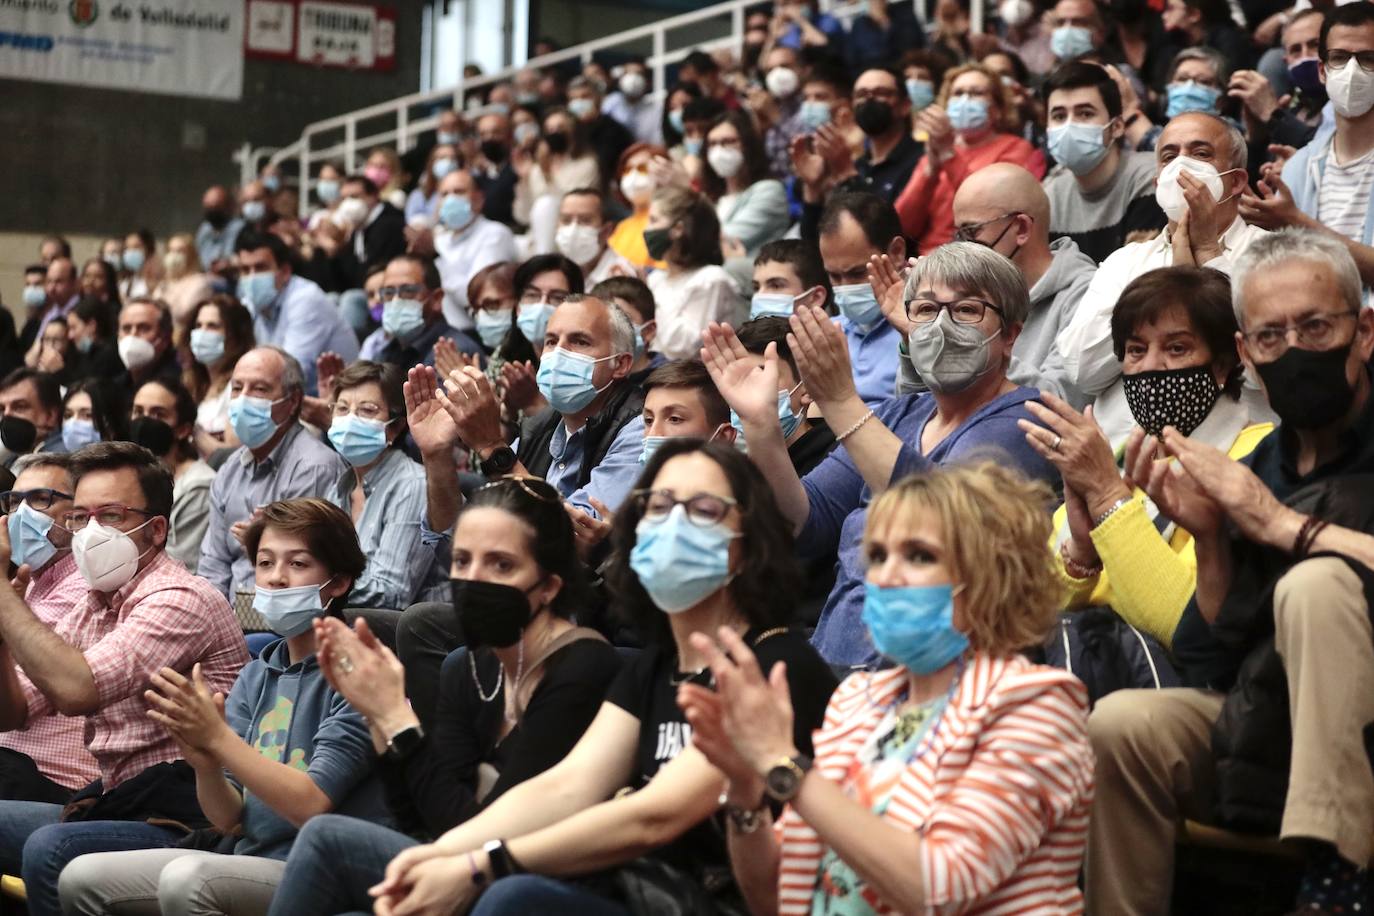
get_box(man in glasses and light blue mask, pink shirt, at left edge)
[0,455,100,805]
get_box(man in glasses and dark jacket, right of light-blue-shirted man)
[357,254,482,373]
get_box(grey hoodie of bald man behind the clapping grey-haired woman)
[897,236,1098,409]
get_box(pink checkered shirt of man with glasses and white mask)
[19,553,249,791]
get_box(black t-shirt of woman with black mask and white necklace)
[382,639,620,836]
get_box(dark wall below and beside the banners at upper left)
[0,0,422,245]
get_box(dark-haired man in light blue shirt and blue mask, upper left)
[235,229,361,394]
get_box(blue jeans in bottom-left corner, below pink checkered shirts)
[0,802,181,916]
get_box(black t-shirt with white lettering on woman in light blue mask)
[606,630,835,873]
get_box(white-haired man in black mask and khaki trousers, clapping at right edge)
[1087,229,1374,916]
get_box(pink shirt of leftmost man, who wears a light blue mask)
[0,551,100,790]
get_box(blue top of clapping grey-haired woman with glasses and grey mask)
[797,387,1058,666]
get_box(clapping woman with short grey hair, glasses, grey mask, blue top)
[702,242,1058,666]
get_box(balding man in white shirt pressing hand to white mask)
[1055,111,1265,445]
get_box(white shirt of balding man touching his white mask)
[1055,217,1265,446]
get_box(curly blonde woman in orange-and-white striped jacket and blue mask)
[679,463,1092,916]
